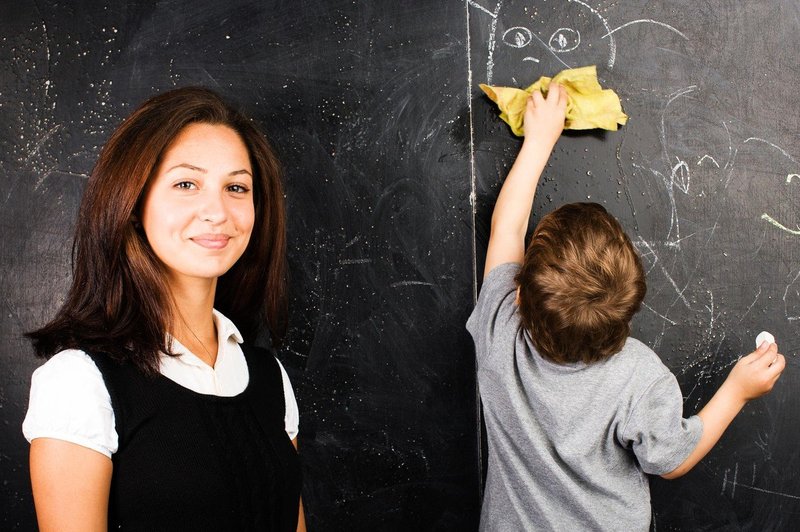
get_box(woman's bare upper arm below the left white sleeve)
[30,438,112,532]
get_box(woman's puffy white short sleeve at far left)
[22,349,118,458]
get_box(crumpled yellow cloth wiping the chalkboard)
[480,65,628,137]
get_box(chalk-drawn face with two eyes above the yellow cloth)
[470,0,615,86]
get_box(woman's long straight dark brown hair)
[27,87,287,373]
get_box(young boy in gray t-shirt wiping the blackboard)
[467,85,785,531]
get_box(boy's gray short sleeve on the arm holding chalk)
[620,372,703,475]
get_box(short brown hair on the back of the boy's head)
[516,203,647,363]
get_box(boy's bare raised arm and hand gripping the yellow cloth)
[483,84,567,277]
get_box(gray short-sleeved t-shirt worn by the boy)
[467,264,703,532]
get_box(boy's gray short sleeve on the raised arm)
[467,263,520,359]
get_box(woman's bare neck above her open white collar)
[172,279,219,368]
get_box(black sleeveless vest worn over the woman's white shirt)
[90,346,300,531]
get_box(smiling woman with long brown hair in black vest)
[23,88,305,531]
